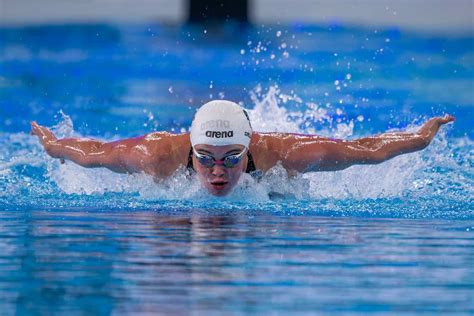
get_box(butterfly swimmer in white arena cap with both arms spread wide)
[31,100,454,196]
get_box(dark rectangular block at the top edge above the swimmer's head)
[188,0,249,23]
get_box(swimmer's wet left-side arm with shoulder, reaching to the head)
[31,122,189,176]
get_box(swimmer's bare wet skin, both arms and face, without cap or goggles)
[31,115,454,196]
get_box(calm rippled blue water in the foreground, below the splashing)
[0,210,474,314]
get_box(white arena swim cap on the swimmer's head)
[191,100,252,148]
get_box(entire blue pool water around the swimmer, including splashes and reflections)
[0,24,474,315]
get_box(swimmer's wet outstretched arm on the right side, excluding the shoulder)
[282,115,454,172]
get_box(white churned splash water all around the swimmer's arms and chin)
[0,94,466,203]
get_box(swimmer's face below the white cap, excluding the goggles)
[193,145,247,196]
